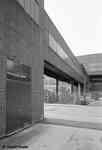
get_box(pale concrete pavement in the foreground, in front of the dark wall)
[0,124,102,150]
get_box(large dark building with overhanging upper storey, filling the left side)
[0,0,101,136]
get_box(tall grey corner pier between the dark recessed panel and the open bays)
[31,28,44,123]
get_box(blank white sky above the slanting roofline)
[45,0,102,56]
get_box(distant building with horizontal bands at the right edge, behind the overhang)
[77,54,102,99]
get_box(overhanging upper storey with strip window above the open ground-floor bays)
[41,9,87,83]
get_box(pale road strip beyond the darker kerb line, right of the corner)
[44,104,102,129]
